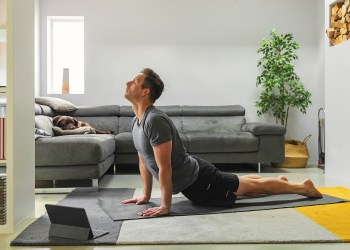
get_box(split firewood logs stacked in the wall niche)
[326,0,350,45]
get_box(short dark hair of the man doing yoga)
[141,68,164,103]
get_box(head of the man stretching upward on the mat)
[124,68,164,103]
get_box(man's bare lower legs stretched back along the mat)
[236,176,322,197]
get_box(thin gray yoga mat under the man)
[99,194,347,221]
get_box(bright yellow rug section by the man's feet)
[295,187,350,242]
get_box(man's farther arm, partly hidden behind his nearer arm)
[122,154,153,205]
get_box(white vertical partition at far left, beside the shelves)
[12,0,35,229]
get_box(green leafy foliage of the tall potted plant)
[255,29,311,128]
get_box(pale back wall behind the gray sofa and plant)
[40,0,324,163]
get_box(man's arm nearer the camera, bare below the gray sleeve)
[139,141,172,216]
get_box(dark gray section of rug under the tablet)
[11,188,135,246]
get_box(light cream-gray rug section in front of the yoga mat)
[117,208,342,245]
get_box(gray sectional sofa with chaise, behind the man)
[35,104,285,186]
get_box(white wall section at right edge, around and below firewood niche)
[324,0,350,183]
